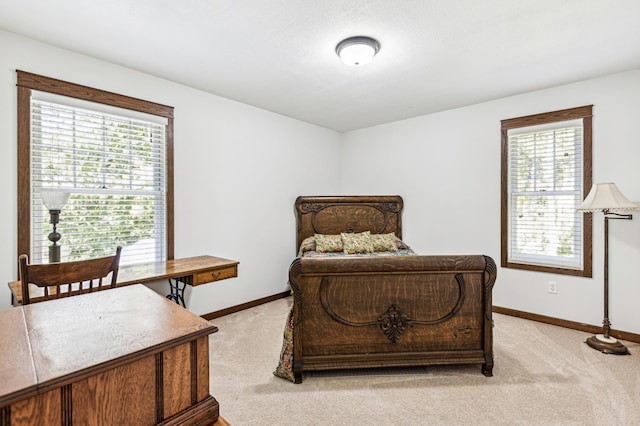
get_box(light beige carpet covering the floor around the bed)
[210,298,640,426]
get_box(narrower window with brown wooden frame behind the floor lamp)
[501,106,592,277]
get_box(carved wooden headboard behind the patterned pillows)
[295,195,404,249]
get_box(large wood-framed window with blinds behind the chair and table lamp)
[18,71,173,265]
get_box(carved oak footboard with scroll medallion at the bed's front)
[289,256,496,383]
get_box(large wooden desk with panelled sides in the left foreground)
[0,285,219,426]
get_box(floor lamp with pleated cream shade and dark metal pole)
[578,182,640,355]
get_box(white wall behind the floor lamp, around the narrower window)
[342,71,640,333]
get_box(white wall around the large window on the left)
[0,31,341,314]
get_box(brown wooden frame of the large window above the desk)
[16,70,174,260]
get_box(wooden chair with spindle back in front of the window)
[19,246,122,305]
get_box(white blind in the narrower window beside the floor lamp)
[508,120,584,269]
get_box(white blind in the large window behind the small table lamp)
[31,92,167,265]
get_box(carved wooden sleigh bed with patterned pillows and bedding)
[274,196,496,383]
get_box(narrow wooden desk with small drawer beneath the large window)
[9,256,240,306]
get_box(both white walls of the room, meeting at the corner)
[0,31,640,333]
